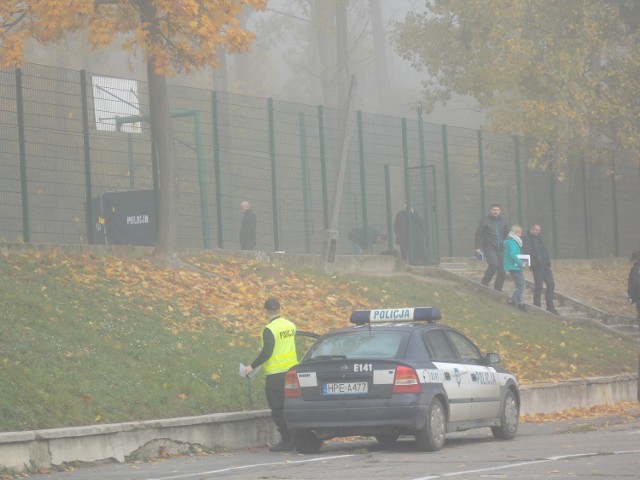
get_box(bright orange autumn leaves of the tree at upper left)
[0,0,267,74]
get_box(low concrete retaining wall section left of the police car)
[0,410,277,472]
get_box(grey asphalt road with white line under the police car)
[29,409,640,480]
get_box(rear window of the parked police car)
[305,330,407,360]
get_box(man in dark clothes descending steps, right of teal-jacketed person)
[522,223,558,315]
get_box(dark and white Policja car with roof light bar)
[284,307,520,453]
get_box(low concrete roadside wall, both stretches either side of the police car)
[0,374,638,472]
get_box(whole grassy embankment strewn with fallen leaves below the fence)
[0,249,637,431]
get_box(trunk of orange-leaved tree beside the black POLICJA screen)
[140,2,179,258]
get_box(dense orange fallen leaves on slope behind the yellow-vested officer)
[23,249,368,335]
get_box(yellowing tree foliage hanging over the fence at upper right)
[394,0,640,169]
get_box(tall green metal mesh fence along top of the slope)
[0,64,640,264]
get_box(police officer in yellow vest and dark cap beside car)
[246,297,298,452]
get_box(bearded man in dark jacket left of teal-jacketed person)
[475,203,511,292]
